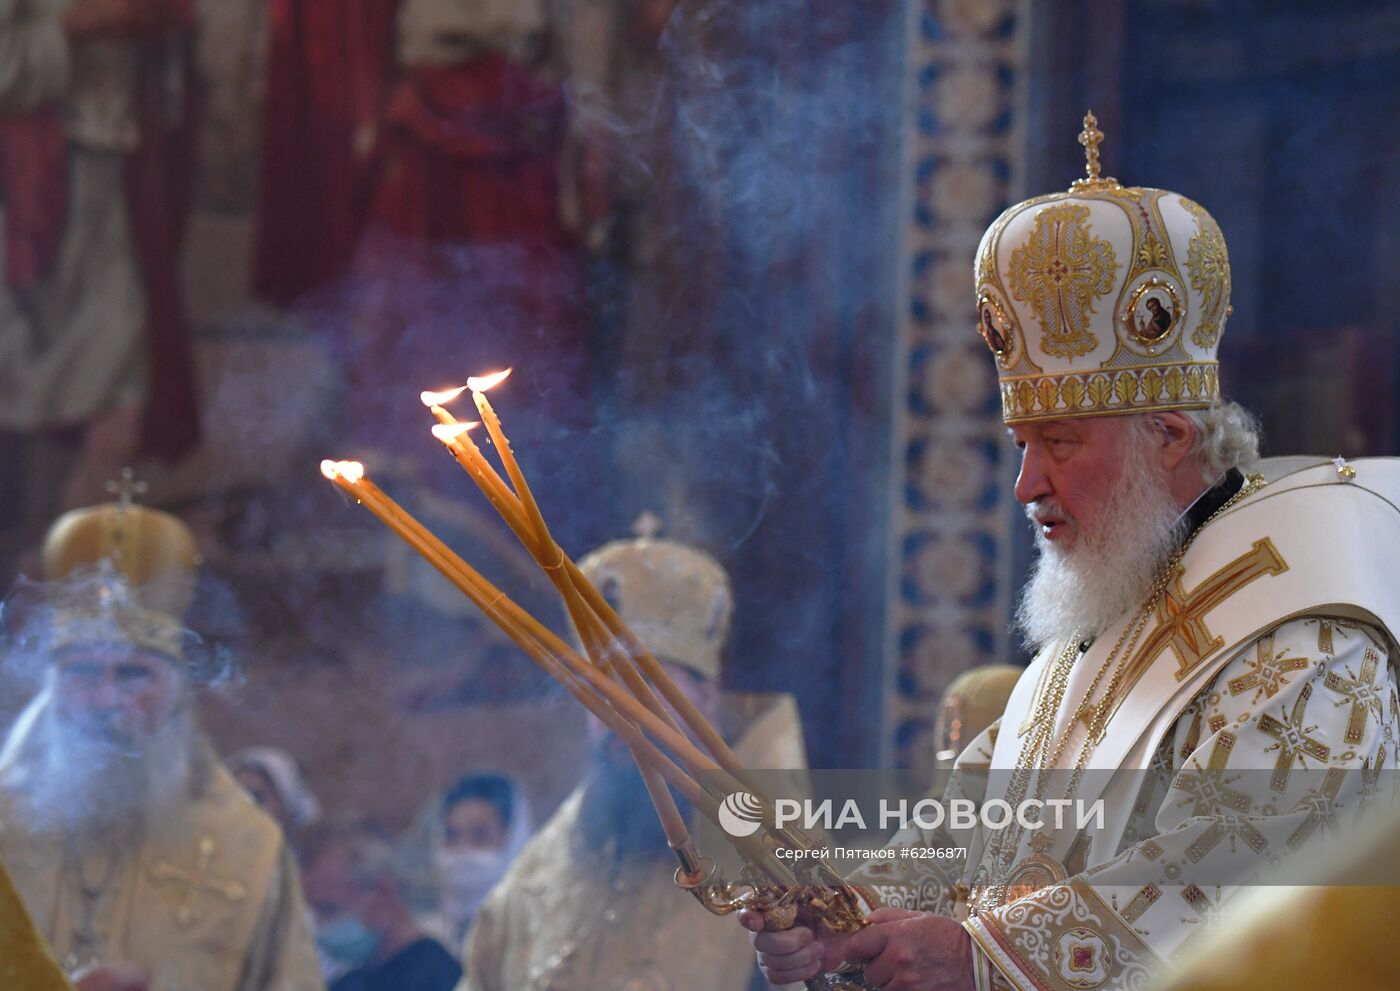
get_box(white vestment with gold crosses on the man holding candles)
[854,459,1400,991]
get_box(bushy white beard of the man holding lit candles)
[1016,437,1186,651]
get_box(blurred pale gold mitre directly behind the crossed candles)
[578,516,734,679]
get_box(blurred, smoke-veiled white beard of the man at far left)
[0,690,199,844]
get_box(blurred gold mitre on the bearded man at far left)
[43,501,199,659]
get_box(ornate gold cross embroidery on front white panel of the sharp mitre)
[1008,203,1119,358]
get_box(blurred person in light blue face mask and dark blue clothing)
[302,819,462,991]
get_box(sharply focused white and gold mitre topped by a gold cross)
[976,112,1231,424]
